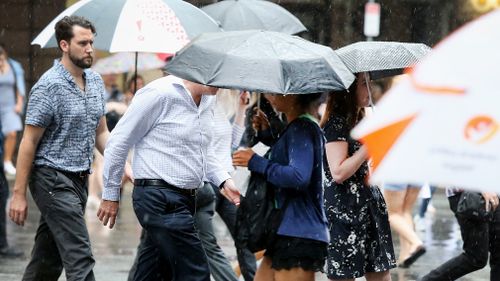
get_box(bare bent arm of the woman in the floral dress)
[325,141,368,183]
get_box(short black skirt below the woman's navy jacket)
[264,235,328,272]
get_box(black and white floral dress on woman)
[324,117,396,279]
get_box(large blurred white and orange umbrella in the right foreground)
[353,10,500,193]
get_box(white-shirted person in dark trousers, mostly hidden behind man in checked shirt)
[195,90,257,281]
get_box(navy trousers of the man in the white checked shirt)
[132,186,210,281]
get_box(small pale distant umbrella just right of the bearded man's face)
[92,53,165,74]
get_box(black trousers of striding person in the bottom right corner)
[422,194,500,281]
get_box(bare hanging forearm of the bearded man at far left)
[9,125,45,225]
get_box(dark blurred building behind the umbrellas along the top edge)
[0,0,500,90]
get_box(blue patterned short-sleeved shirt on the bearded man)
[25,60,104,172]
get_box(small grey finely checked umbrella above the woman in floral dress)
[336,41,431,79]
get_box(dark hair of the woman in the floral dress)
[320,78,365,129]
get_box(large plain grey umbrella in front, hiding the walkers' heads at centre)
[166,30,354,94]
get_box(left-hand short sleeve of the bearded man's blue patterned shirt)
[25,83,54,128]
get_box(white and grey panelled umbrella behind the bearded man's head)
[32,0,220,53]
